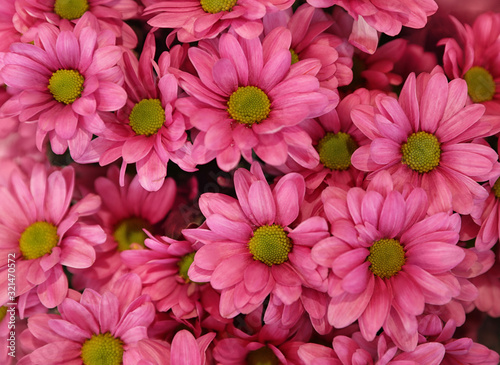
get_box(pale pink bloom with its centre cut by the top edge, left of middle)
[143,0,293,45]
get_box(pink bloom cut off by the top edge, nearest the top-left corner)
[15,0,139,49]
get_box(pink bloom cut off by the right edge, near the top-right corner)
[438,12,500,116]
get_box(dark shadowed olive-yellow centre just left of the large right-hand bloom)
[316,132,358,171]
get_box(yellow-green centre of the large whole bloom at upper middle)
[227,86,271,126]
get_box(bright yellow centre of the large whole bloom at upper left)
[48,69,85,104]
